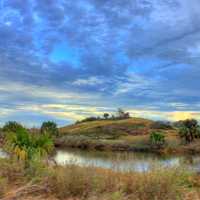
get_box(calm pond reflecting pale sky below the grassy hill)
[54,149,200,172]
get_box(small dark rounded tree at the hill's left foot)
[41,121,58,136]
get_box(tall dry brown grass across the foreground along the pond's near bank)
[0,159,197,200]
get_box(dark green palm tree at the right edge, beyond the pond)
[179,119,200,143]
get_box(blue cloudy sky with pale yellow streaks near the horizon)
[0,0,200,126]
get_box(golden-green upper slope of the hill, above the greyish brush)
[60,118,153,137]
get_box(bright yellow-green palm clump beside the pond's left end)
[5,127,53,160]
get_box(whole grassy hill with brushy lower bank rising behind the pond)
[56,118,180,151]
